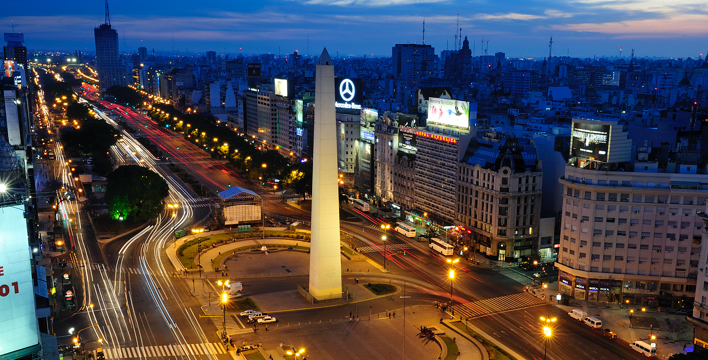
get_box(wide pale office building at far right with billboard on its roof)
[556,119,708,307]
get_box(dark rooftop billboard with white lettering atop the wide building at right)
[570,122,612,161]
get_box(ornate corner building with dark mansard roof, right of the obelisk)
[455,132,543,261]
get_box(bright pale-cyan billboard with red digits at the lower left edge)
[0,206,39,357]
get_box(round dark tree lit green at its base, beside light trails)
[105,165,169,221]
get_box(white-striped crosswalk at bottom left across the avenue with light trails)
[103,343,227,359]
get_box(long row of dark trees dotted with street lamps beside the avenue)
[148,104,312,196]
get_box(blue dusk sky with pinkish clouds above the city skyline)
[5,0,708,58]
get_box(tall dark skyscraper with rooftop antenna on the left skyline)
[93,0,127,93]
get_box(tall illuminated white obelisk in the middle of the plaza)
[309,48,342,300]
